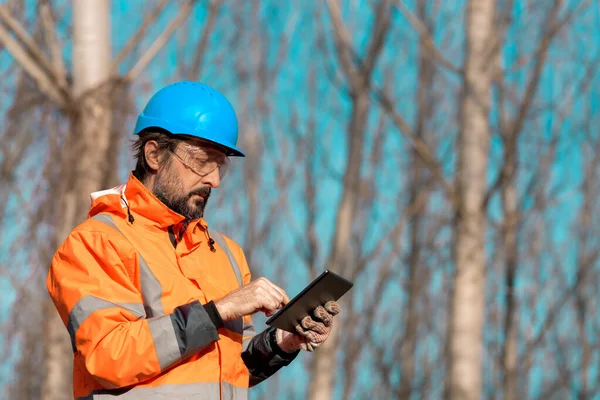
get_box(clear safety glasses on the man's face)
[167,143,230,179]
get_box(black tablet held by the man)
[266,270,354,333]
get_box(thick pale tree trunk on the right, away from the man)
[446,0,495,400]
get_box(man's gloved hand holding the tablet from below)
[276,301,340,353]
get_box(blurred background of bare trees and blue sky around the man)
[0,0,600,400]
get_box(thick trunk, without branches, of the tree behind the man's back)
[41,0,116,400]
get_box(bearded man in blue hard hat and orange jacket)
[47,82,339,400]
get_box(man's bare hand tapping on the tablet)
[215,278,290,321]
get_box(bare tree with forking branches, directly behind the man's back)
[0,0,191,400]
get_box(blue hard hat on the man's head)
[134,81,245,157]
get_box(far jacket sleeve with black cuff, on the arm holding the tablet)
[236,241,300,386]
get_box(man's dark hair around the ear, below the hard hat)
[131,129,182,182]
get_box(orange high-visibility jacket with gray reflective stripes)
[46,175,297,400]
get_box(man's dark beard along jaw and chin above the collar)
[152,167,211,220]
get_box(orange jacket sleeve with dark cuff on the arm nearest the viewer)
[46,230,219,389]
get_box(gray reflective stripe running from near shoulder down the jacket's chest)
[92,213,165,318]
